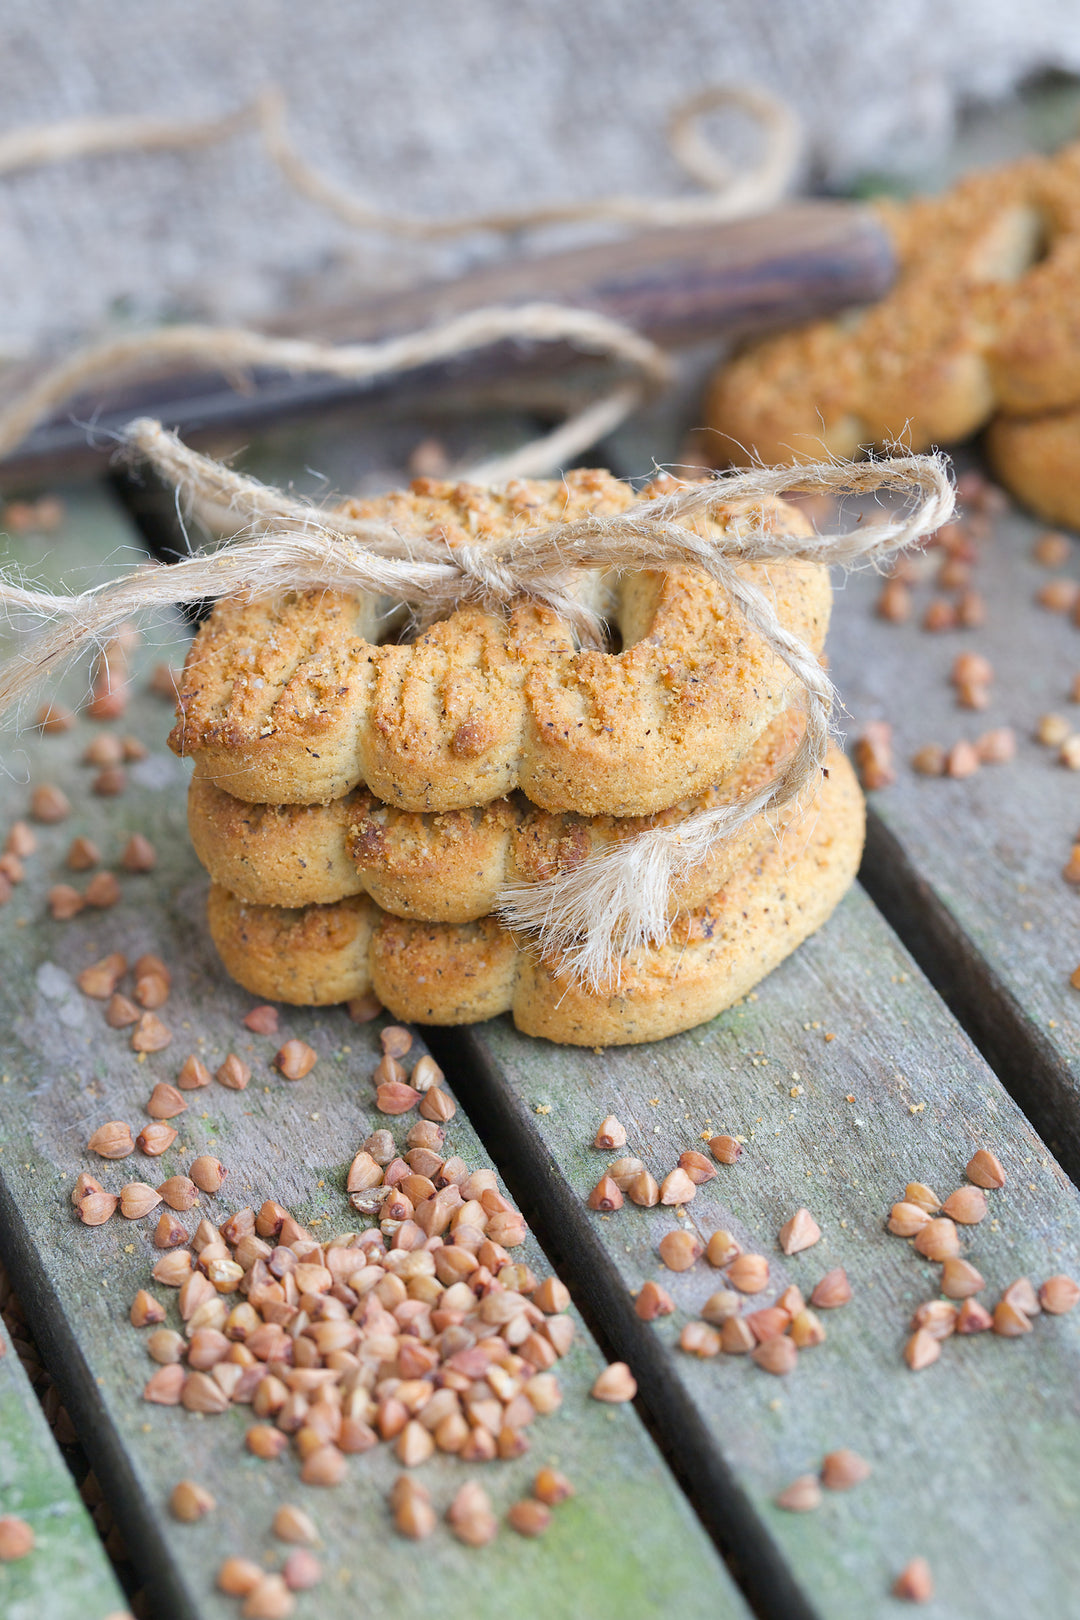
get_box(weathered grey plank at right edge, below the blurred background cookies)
[829,473,1080,1178]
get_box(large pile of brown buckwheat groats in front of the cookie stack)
[71,1030,636,1620]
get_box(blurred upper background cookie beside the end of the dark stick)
[706,144,1080,463]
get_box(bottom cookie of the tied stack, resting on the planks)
[209,748,863,1047]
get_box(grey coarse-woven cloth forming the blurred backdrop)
[0,0,1080,356]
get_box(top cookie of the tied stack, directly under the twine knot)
[170,471,831,816]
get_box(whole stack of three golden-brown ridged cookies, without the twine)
[170,471,863,1045]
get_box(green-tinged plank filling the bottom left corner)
[0,1283,128,1620]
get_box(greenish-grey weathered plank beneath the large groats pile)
[0,499,746,1620]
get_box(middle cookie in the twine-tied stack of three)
[188,710,805,922]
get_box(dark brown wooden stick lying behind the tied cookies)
[0,201,894,470]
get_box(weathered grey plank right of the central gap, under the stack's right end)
[436,891,1080,1620]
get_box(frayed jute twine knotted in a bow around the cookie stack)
[0,420,955,991]
